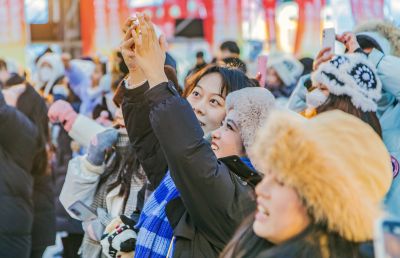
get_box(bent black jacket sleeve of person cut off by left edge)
[0,93,38,171]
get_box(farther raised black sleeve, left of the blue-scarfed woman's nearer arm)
[122,83,168,190]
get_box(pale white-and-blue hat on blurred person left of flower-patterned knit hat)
[268,54,304,86]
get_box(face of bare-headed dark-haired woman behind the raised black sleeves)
[187,73,225,134]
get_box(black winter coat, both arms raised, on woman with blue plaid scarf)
[123,82,255,258]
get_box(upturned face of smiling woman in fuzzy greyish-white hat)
[211,111,246,158]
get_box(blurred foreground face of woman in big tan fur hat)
[253,172,310,244]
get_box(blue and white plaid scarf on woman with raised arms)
[135,158,253,258]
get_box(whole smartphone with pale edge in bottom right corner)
[374,218,400,258]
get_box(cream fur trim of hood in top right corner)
[354,20,400,57]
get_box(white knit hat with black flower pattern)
[311,53,382,112]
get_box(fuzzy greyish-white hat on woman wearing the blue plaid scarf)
[225,87,275,151]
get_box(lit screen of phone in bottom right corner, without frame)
[382,221,400,258]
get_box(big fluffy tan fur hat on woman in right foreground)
[253,110,392,242]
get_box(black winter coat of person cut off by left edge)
[0,93,38,258]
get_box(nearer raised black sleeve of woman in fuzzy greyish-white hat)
[146,82,240,239]
